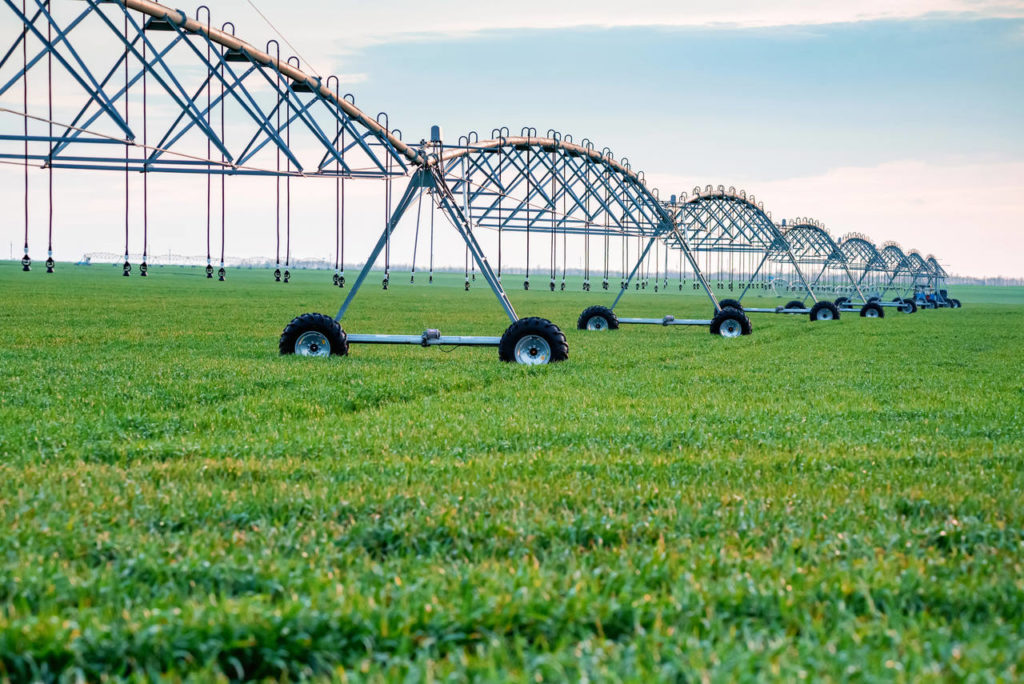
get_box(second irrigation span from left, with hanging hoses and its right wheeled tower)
[442,129,750,337]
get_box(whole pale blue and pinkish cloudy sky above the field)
[0,0,1024,277]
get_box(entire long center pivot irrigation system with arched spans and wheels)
[0,0,959,365]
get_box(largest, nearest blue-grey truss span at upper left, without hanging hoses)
[0,0,422,178]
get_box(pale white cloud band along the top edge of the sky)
[217,0,1024,57]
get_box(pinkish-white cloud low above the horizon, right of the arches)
[647,161,1024,277]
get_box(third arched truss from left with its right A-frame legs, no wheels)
[667,185,817,311]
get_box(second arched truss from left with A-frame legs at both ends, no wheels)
[336,129,720,325]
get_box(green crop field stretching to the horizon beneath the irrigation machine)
[0,263,1024,681]
